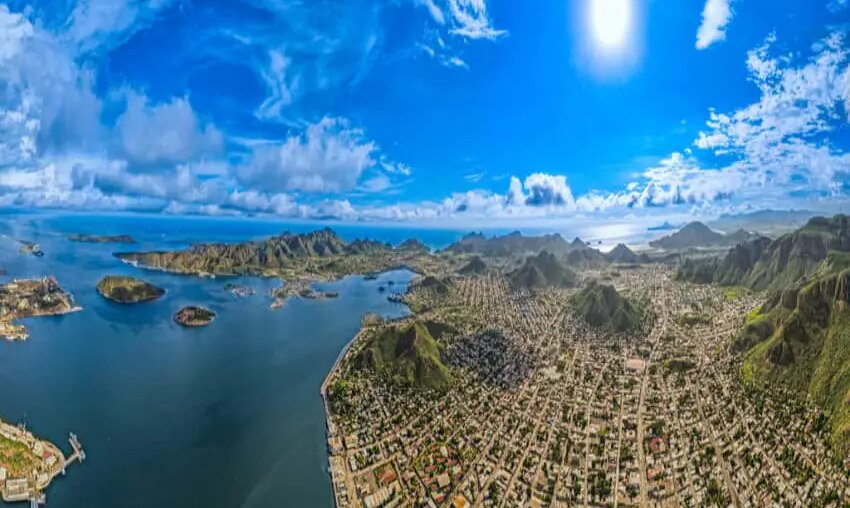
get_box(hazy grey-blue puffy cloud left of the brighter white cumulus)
[115,92,224,167]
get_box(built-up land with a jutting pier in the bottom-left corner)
[0,420,86,506]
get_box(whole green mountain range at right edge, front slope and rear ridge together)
[676,215,850,452]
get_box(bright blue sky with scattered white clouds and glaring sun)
[0,0,850,227]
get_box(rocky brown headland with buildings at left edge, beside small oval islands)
[0,276,81,340]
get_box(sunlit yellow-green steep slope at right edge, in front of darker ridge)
[734,253,850,451]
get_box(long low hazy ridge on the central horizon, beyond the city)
[446,231,572,257]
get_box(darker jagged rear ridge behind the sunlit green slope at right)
[676,215,850,290]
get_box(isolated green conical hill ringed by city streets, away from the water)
[572,281,643,332]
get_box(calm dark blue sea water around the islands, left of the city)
[0,214,422,508]
